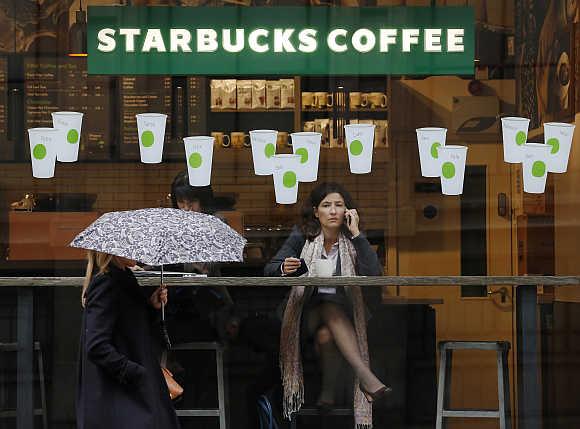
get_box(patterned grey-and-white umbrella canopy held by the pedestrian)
[70,208,246,265]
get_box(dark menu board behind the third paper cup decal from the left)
[120,76,173,160]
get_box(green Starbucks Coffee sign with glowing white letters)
[87,6,475,75]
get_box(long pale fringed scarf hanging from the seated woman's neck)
[280,233,373,429]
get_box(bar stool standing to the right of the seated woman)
[436,341,512,429]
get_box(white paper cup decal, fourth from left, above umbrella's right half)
[183,136,214,186]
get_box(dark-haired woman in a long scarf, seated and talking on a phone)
[264,183,391,429]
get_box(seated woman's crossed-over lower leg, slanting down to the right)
[317,302,384,392]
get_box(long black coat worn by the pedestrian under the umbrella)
[77,267,179,429]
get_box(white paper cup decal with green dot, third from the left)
[135,113,167,164]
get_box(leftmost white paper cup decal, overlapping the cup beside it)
[28,128,62,179]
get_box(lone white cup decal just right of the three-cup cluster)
[344,124,375,174]
